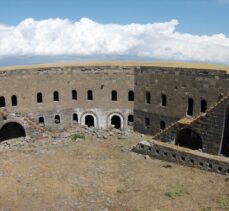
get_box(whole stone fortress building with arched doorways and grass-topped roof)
[0,62,229,173]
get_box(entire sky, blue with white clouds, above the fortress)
[0,0,229,65]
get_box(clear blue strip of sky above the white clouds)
[0,0,229,35]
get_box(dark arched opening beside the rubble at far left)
[0,122,26,142]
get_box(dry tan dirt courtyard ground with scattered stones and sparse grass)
[0,130,229,211]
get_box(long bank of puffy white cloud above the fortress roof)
[0,18,229,63]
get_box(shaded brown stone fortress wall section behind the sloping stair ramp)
[134,67,229,134]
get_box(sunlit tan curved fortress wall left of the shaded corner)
[0,67,134,129]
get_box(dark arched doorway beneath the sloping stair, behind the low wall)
[176,128,202,150]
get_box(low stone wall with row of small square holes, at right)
[133,141,229,175]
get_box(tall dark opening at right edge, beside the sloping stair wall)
[221,106,229,157]
